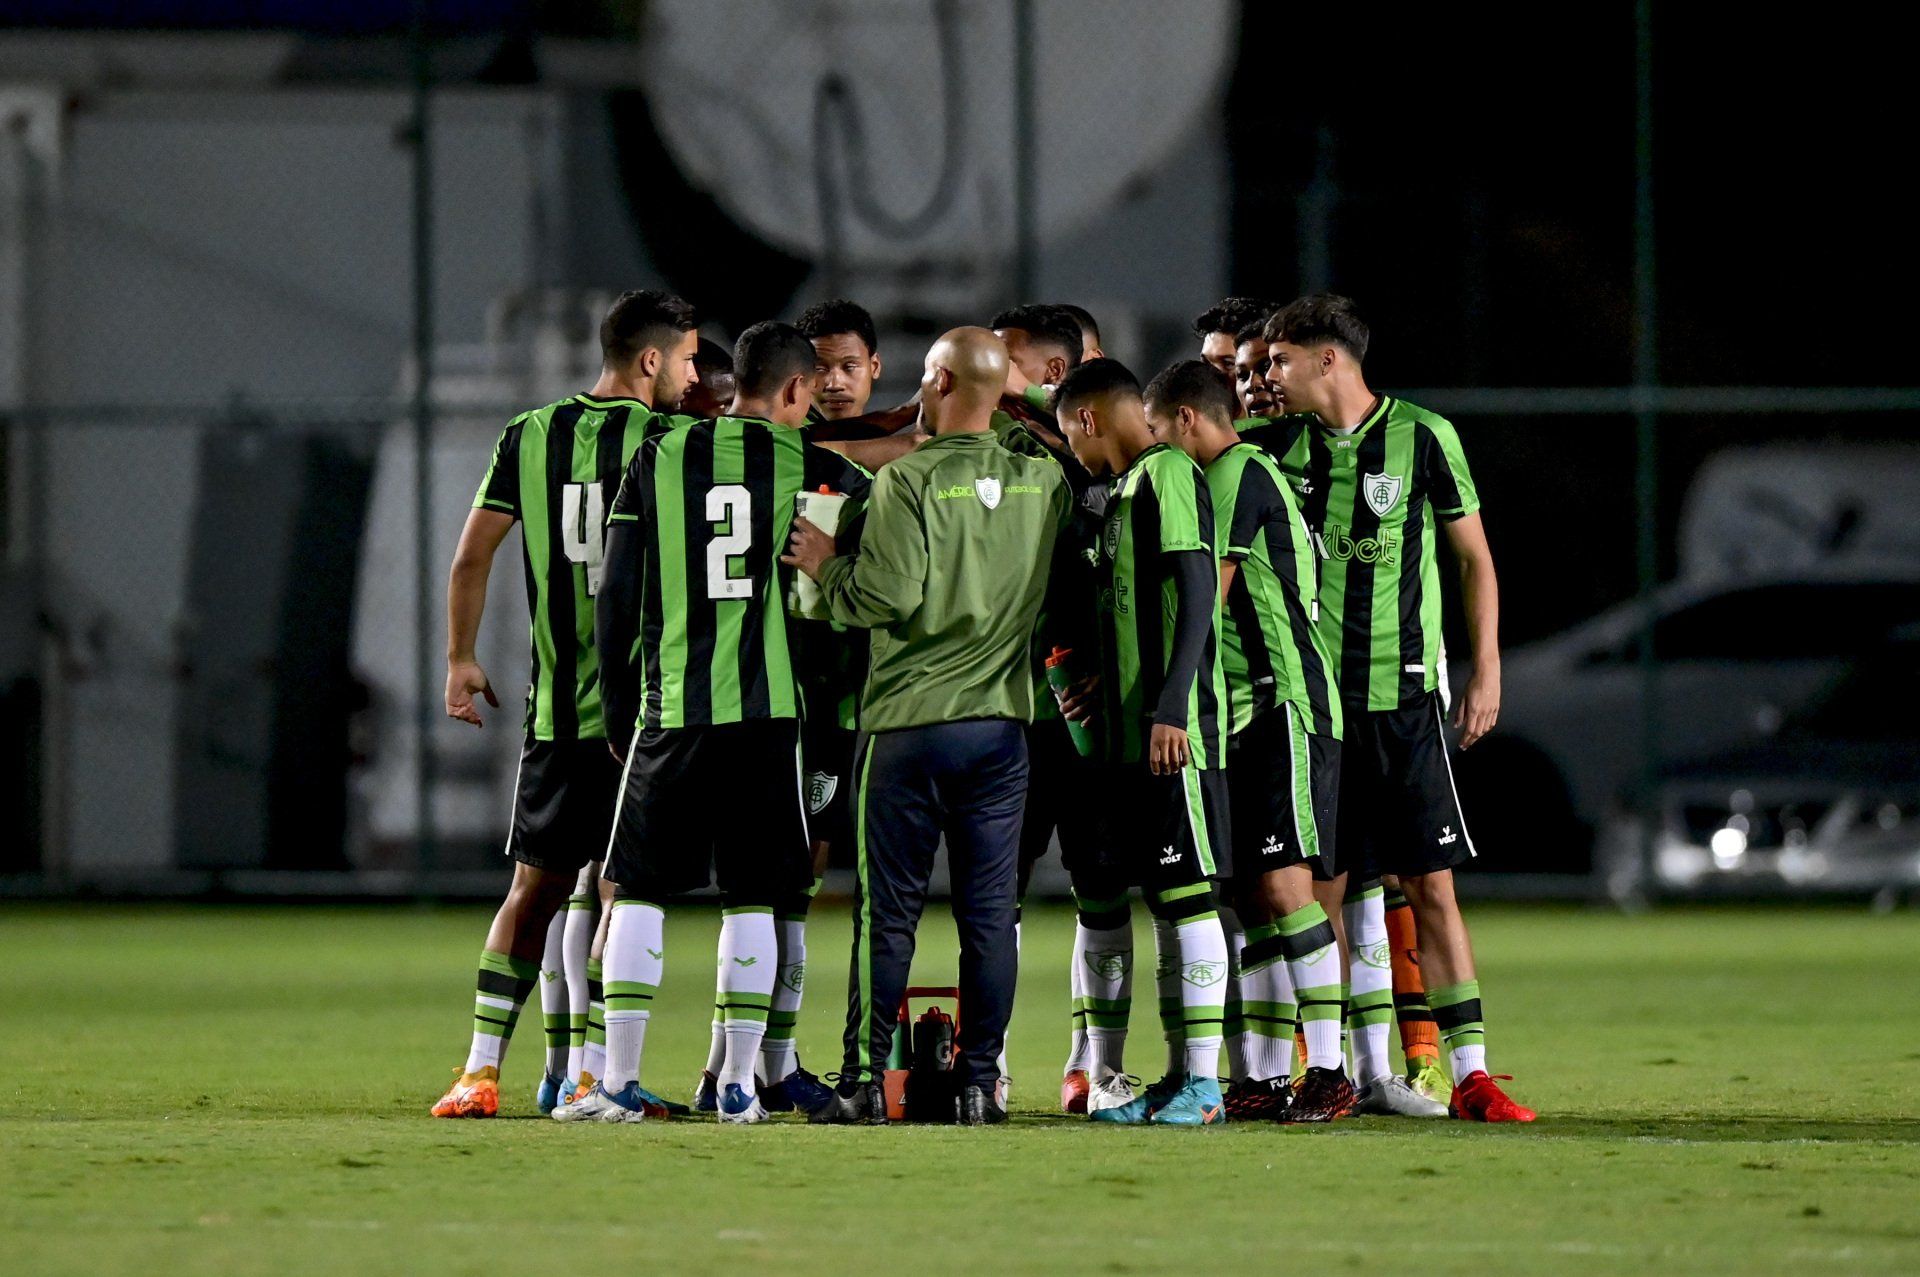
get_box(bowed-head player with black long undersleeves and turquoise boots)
[1056,359,1231,1125]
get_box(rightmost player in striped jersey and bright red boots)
[1265,294,1534,1121]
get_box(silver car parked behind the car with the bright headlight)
[1452,563,1920,872]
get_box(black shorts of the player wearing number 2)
[607,718,814,904]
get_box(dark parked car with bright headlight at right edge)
[1601,628,1920,899]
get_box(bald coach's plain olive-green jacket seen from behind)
[820,434,1071,732]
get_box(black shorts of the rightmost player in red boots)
[1340,691,1475,881]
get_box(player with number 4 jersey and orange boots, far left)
[432,292,699,1118]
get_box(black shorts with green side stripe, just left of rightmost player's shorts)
[1227,701,1340,881]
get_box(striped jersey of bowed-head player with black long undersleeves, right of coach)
[1096,444,1227,770]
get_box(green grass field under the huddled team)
[0,904,1920,1277]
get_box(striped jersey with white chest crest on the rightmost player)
[1244,396,1480,711]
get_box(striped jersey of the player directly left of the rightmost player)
[1206,444,1340,739]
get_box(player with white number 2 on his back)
[553,323,868,1121]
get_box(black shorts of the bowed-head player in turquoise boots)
[1102,762,1233,891]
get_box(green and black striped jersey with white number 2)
[609,417,872,728]
